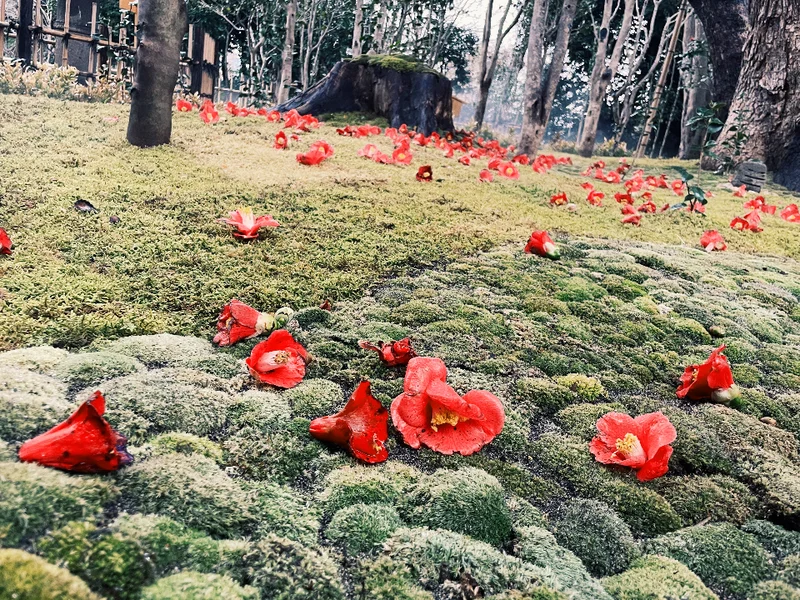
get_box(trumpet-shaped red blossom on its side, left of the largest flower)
[308,381,389,464]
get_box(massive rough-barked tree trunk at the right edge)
[715,0,800,190]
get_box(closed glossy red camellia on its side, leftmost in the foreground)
[19,392,133,473]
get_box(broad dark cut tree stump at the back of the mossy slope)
[277,57,453,135]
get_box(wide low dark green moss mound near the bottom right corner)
[645,523,772,598]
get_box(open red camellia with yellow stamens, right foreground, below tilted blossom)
[589,412,678,481]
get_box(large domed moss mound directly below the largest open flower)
[404,467,511,545]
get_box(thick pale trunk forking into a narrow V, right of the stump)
[519,0,578,156]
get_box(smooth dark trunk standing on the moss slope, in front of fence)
[128,0,189,148]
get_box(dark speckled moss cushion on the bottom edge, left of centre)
[245,535,345,600]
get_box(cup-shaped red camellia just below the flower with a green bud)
[244,329,308,389]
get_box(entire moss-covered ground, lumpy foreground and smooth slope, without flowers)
[0,97,800,600]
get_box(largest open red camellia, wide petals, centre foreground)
[392,357,505,456]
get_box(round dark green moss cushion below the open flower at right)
[551,500,639,577]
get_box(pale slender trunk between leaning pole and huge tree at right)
[678,12,711,160]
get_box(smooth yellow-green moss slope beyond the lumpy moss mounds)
[0,96,800,349]
